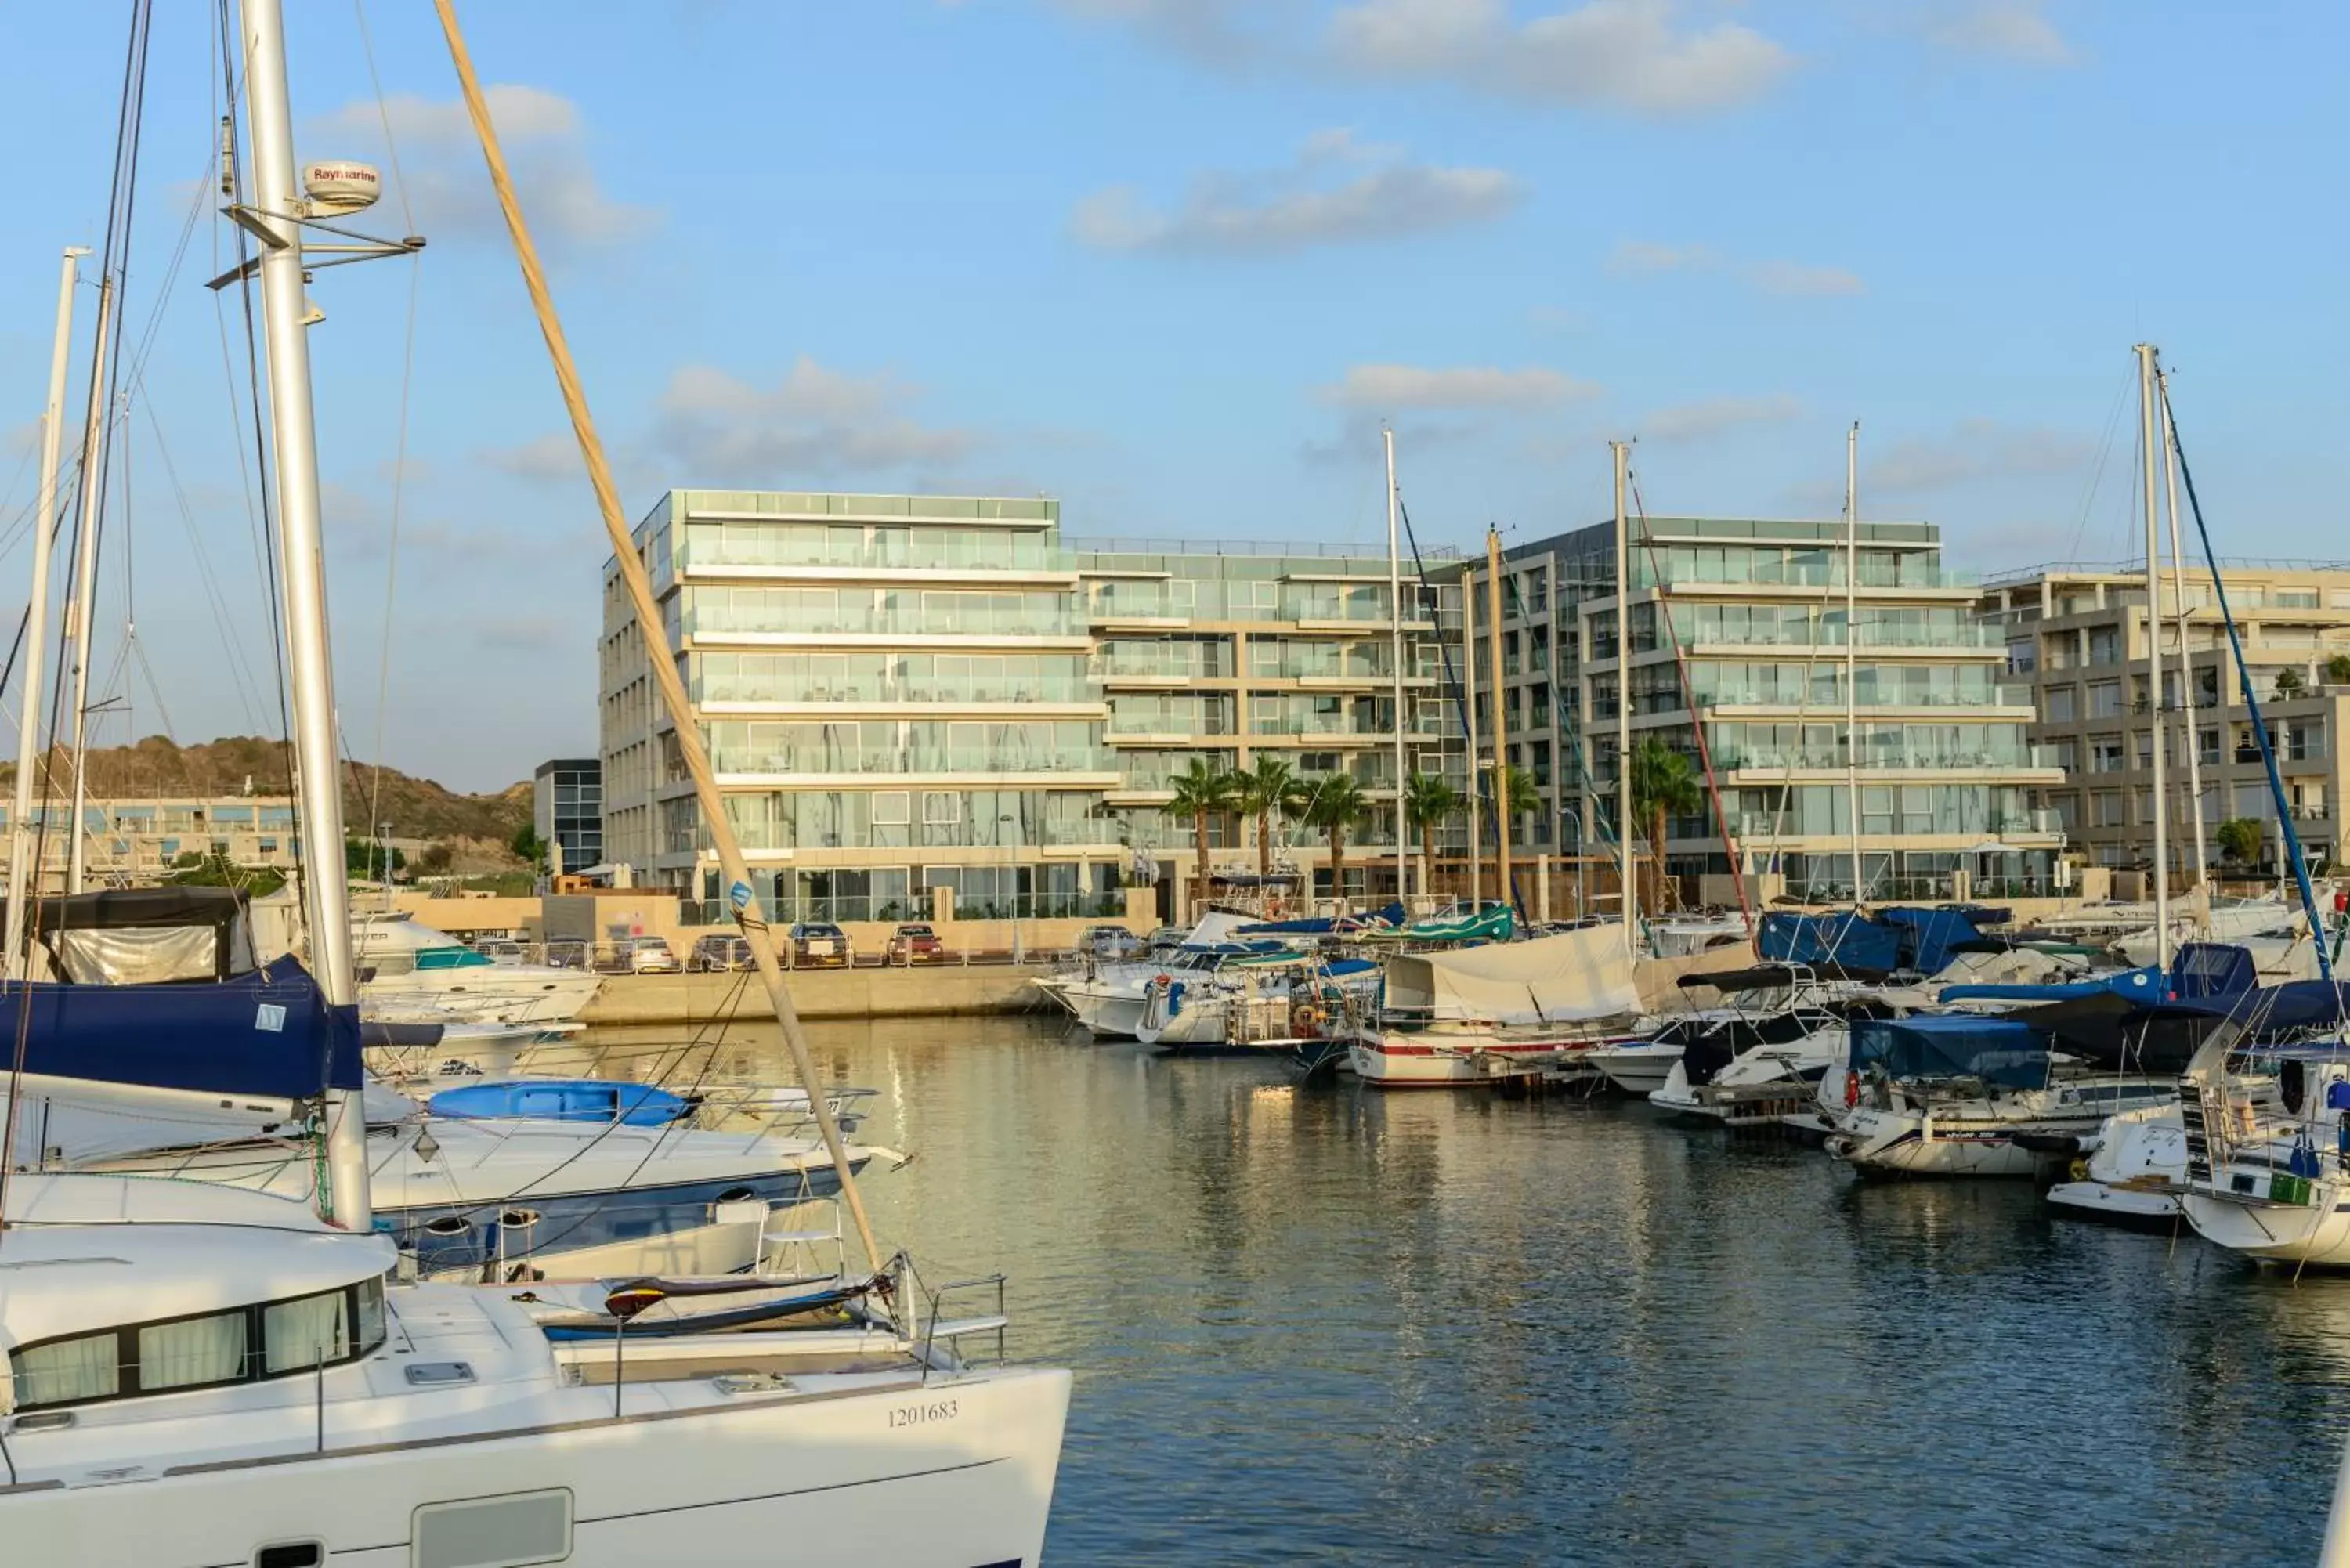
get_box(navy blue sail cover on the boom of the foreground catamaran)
[0,959,364,1100]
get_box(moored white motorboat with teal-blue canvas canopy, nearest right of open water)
[1826,1016,2178,1178]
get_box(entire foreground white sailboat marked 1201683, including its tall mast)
[0,0,1069,1568]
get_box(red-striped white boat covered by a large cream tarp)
[1347,927,1643,1089]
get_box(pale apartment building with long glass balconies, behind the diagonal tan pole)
[602,491,1448,919]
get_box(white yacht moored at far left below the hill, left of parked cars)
[350,915,604,1025]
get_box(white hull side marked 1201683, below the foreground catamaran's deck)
[0,1371,1069,1568]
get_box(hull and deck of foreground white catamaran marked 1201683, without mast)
[0,1176,1069,1568]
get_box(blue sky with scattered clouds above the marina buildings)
[0,0,2350,790]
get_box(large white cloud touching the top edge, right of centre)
[1325,0,1795,115]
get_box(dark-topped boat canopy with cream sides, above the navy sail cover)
[33,887,258,985]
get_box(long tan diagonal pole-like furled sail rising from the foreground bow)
[432,0,881,1274]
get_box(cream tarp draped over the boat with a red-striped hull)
[1386,927,1640,1023]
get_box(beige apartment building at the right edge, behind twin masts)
[1981,562,2350,875]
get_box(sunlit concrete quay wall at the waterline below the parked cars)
[580,964,1048,1025]
